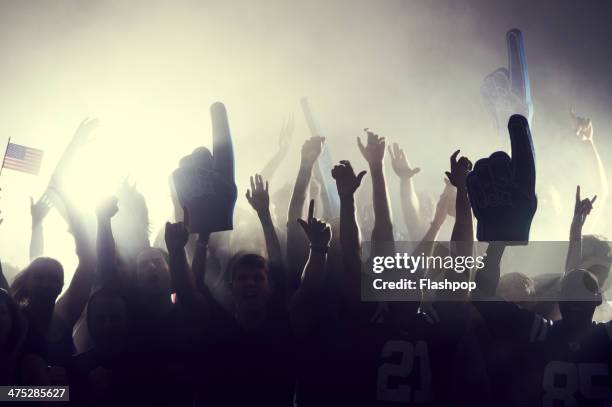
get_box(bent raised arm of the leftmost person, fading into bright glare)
[55,195,96,328]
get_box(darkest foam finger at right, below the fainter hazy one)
[467,115,537,244]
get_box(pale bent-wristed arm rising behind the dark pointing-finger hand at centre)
[287,137,325,288]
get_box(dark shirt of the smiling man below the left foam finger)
[195,305,296,407]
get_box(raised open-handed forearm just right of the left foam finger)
[246,174,283,266]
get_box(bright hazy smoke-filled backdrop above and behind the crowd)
[0,0,612,280]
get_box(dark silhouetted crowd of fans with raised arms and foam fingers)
[0,107,612,407]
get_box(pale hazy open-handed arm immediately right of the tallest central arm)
[389,143,426,241]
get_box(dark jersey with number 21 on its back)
[302,303,474,407]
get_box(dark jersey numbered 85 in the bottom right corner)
[478,302,612,407]
